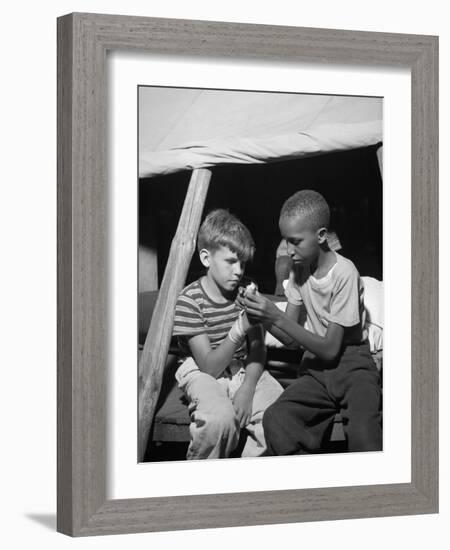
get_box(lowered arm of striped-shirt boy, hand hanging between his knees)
[233,325,266,428]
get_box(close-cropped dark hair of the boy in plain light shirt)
[280,189,330,229]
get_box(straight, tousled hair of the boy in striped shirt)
[197,208,255,262]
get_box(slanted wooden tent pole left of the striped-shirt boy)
[138,168,211,462]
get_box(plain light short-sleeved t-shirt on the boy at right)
[285,252,367,344]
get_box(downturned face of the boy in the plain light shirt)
[280,216,326,265]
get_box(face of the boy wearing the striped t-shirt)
[200,246,245,292]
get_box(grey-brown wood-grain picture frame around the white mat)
[57,13,438,536]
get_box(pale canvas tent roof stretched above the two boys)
[139,87,382,177]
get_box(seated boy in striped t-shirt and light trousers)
[174,209,283,459]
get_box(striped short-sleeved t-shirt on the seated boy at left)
[173,280,247,359]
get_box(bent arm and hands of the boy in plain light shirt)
[245,295,344,361]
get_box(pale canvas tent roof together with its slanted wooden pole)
[139,87,382,459]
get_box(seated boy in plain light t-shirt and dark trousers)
[243,190,382,455]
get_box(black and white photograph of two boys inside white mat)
[137,86,388,462]
